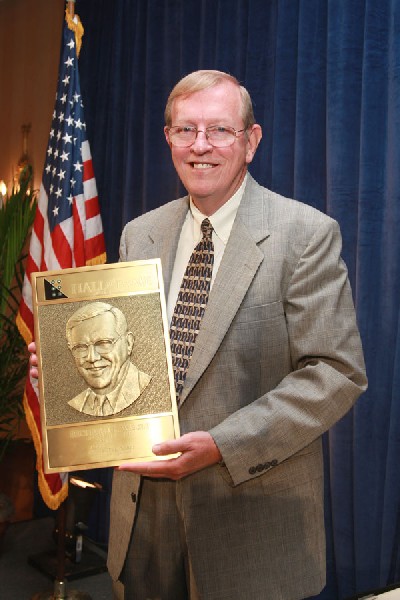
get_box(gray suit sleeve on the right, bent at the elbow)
[210,219,366,485]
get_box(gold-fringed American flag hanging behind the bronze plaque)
[17,17,106,510]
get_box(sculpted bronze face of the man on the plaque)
[70,312,133,394]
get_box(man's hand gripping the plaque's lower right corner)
[118,431,222,481]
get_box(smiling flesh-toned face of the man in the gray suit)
[165,81,261,215]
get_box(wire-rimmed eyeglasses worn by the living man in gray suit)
[168,125,246,148]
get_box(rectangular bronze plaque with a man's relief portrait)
[32,259,179,473]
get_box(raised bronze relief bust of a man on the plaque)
[66,302,151,417]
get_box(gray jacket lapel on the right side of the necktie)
[181,176,269,403]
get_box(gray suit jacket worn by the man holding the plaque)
[108,177,366,600]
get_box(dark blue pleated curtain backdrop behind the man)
[69,0,400,600]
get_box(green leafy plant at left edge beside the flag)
[0,167,36,461]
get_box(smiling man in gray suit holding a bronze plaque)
[31,71,366,600]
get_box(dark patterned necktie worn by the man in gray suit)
[170,219,214,403]
